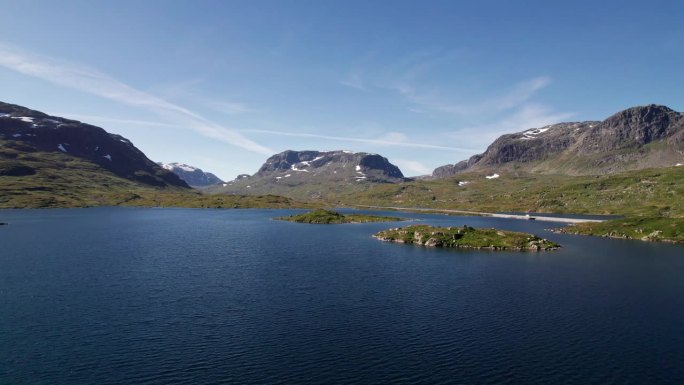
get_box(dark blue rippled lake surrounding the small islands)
[0,208,684,385]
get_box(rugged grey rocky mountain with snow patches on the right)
[432,104,684,178]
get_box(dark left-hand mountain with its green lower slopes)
[0,102,190,207]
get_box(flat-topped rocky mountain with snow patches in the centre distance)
[209,151,405,199]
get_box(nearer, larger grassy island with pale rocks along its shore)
[373,225,560,251]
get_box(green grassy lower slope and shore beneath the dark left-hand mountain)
[0,145,309,208]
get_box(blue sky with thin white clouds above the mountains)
[0,0,684,179]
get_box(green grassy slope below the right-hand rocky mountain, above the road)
[334,167,684,217]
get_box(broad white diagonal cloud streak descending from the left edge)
[0,44,273,154]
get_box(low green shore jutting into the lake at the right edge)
[554,217,684,243]
